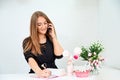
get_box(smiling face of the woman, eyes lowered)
[37,16,48,34]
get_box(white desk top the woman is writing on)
[0,67,120,80]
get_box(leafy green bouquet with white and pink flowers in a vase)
[80,42,104,73]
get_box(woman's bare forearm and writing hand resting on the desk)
[28,58,51,77]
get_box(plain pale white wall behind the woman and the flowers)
[0,0,120,74]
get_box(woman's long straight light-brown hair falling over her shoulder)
[23,11,52,55]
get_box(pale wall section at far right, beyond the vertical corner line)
[98,0,120,69]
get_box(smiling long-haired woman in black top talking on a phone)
[23,11,63,77]
